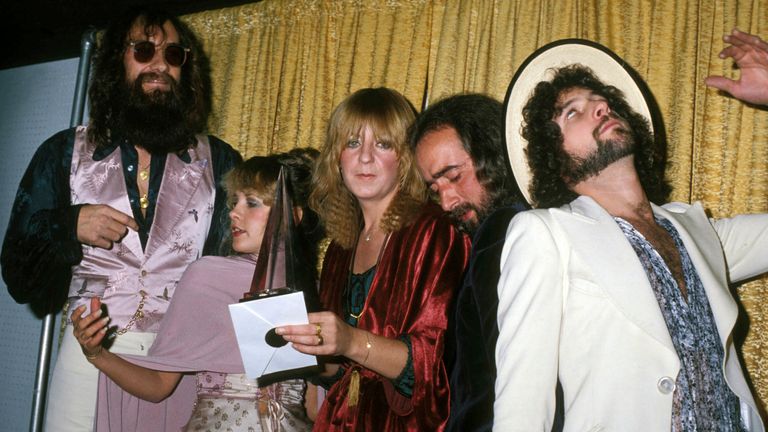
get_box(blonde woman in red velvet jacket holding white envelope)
[278,88,470,431]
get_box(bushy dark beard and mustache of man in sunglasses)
[118,72,196,155]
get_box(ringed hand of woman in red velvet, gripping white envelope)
[275,312,356,357]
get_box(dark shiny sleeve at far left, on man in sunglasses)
[0,129,82,313]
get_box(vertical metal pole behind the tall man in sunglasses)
[29,30,96,432]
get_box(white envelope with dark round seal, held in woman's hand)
[229,291,317,380]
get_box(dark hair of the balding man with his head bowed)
[409,93,525,210]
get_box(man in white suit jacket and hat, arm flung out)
[494,32,768,432]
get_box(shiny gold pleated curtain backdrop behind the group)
[184,0,768,407]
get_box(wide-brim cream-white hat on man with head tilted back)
[504,39,653,203]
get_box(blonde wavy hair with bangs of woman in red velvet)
[309,87,427,249]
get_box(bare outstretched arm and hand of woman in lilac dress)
[70,297,182,402]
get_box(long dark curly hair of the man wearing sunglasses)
[88,8,210,145]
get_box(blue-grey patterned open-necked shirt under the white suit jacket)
[614,217,744,432]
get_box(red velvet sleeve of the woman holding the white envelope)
[385,209,470,430]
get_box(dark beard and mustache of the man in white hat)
[563,117,635,185]
